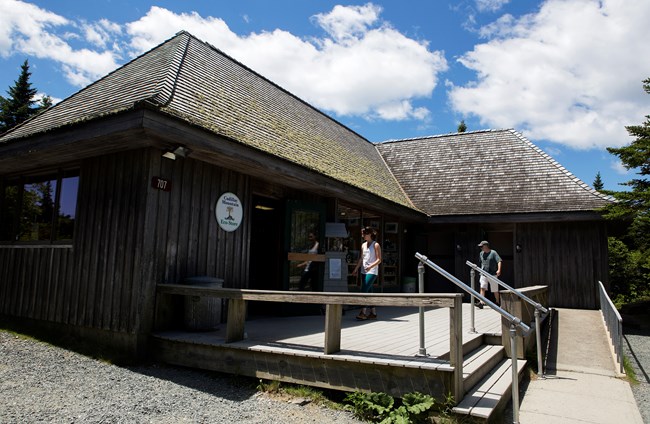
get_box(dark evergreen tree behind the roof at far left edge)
[0,60,40,134]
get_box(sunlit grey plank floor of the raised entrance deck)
[156,304,501,366]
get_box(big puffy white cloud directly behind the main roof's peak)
[126,4,447,120]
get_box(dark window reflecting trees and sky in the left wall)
[0,170,79,243]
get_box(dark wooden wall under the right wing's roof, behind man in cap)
[421,221,608,309]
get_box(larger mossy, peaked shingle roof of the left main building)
[0,32,413,208]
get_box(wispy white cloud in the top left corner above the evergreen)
[0,0,117,86]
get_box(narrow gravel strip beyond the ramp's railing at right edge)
[623,315,650,424]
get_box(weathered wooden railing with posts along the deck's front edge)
[157,284,464,400]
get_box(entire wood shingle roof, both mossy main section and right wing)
[0,32,611,216]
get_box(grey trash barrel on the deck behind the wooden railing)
[183,276,223,331]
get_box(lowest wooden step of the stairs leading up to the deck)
[453,358,526,421]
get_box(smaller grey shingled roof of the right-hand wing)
[377,130,611,216]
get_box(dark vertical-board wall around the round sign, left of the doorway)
[0,149,250,350]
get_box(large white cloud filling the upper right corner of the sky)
[449,0,650,148]
